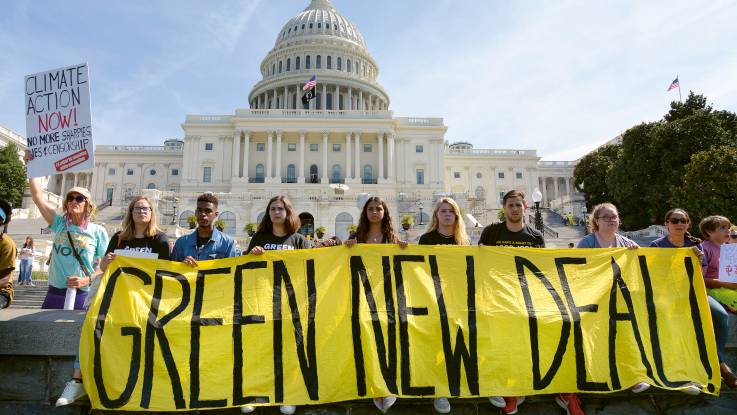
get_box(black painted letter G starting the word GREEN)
[93,267,151,409]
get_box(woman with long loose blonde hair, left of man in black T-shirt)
[419,197,470,414]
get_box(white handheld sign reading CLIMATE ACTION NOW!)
[25,63,95,177]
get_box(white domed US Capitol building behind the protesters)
[10,0,582,242]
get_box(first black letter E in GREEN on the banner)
[189,268,231,409]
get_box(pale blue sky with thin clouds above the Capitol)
[0,0,737,160]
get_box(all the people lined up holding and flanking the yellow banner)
[0,157,737,415]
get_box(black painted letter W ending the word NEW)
[428,255,479,396]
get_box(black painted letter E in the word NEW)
[394,255,435,396]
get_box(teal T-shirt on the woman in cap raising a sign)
[49,213,108,291]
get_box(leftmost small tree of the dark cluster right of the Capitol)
[573,144,622,212]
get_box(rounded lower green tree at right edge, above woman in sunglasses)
[671,146,737,231]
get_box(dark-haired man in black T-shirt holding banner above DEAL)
[479,190,540,414]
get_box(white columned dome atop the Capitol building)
[249,0,389,111]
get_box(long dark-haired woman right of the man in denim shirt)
[241,196,312,415]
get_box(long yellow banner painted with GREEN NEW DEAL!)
[80,245,720,411]
